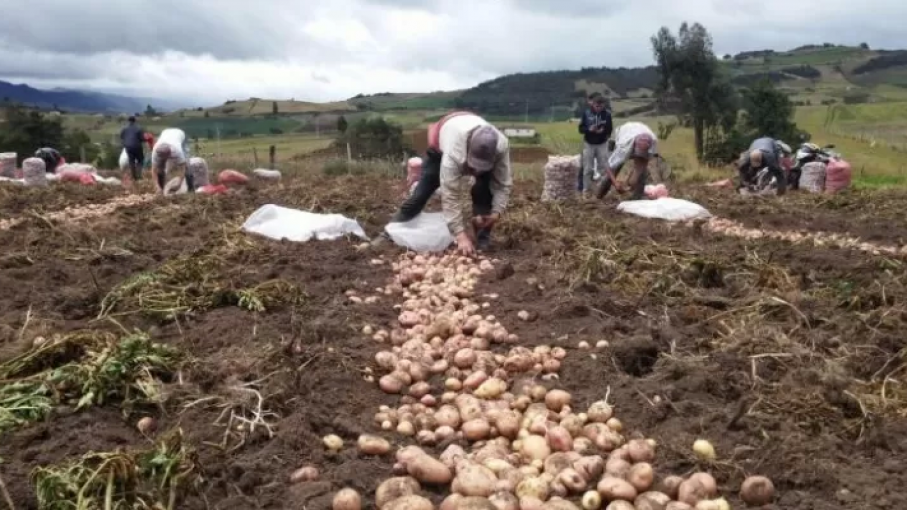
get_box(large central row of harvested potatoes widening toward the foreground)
[325,253,774,510]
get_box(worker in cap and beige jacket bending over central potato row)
[375,112,513,256]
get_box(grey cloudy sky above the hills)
[0,0,907,105]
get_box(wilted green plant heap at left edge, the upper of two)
[0,331,177,432]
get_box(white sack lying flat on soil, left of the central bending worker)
[242,204,368,243]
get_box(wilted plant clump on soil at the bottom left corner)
[32,430,202,510]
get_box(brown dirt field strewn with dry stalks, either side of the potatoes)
[0,176,907,510]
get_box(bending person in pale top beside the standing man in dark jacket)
[596,122,658,200]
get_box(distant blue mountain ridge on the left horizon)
[0,81,179,113]
